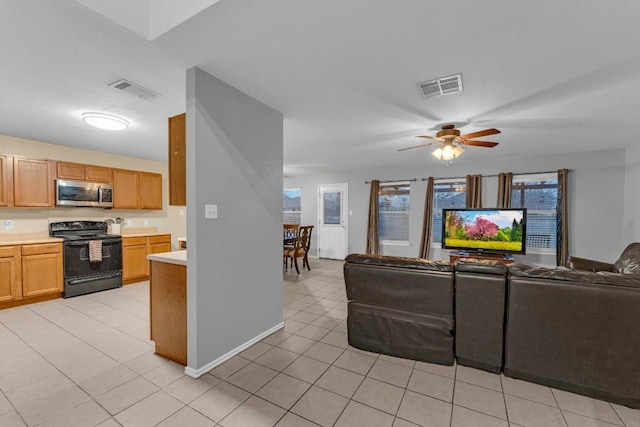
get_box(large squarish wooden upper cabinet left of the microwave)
[13,157,54,208]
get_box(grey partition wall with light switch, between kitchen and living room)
[187,68,283,376]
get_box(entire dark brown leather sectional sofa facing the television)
[344,251,640,408]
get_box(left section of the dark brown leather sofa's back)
[344,254,454,365]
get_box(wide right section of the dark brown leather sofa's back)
[504,264,640,408]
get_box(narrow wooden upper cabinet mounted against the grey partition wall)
[169,113,187,206]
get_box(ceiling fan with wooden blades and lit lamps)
[398,125,500,161]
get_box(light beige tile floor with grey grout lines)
[0,260,640,427]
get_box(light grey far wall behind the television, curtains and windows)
[285,150,624,266]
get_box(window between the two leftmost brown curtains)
[378,182,409,244]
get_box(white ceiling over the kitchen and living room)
[0,0,640,175]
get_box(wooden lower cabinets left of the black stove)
[0,243,64,309]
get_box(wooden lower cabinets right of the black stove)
[122,234,171,285]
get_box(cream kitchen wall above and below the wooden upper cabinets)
[0,135,187,249]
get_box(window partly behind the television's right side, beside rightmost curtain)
[511,173,558,252]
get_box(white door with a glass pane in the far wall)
[318,184,348,259]
